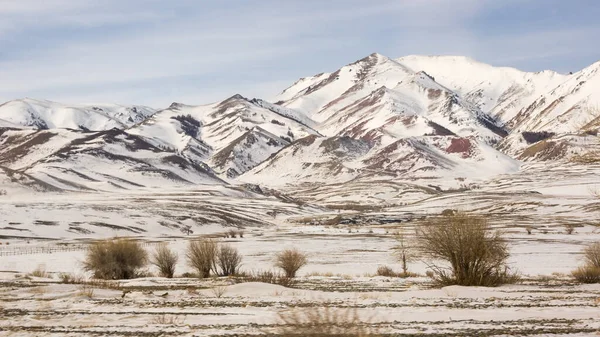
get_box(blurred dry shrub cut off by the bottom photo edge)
[277,307,378,337]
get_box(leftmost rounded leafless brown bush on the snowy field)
[83,239,148,280]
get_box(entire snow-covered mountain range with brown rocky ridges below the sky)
[0,53,600,199]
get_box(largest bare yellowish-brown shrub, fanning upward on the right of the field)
[417,213,518,286]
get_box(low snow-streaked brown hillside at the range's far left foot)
[0,129,224,191]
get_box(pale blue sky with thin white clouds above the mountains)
[0,0,600,107]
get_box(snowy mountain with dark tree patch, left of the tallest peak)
[128,95,318,178]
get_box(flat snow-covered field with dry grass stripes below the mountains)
[0,165,600,336]
